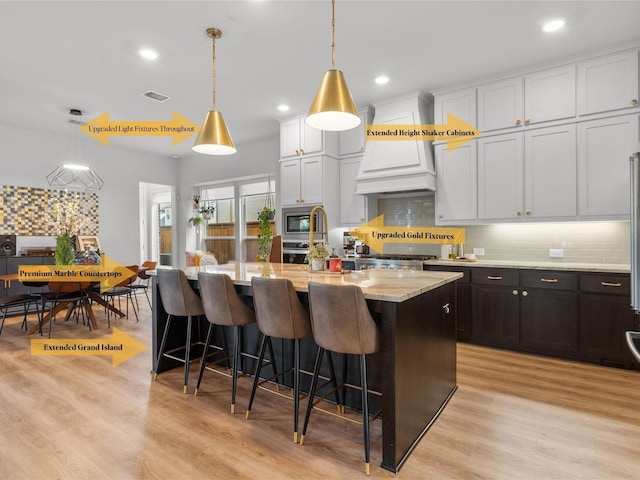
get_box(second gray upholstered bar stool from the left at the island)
[195,272,256,413]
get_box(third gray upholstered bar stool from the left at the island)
[246,277,313,443]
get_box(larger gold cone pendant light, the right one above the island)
[305,0,360,131]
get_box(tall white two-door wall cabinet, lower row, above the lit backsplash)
[478,124,577,221]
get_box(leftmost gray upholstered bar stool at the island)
[153,269,204,393]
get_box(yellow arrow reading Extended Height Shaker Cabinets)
[366,113,482,151]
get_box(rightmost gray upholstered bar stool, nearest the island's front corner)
[300,282,381,475]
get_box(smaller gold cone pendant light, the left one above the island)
[192,28,237,155]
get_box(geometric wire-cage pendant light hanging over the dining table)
[47,108,104,192]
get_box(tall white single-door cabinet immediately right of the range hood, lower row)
[435,141,478,225]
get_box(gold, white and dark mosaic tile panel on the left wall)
[0,185,99,236]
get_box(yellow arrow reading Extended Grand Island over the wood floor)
[31,327,148,367]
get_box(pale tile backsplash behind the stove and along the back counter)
[378,193,631,264]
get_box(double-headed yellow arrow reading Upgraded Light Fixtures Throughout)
[79,112,200,145]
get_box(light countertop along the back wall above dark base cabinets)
[424,260,631,273]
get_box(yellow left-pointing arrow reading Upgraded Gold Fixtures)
[349,215,465,253]
